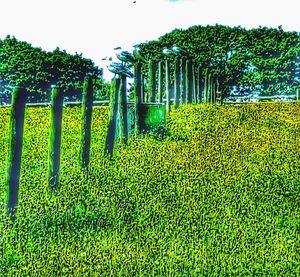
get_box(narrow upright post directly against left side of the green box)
[134,63,142,134]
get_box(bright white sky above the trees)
[0,0,300,80]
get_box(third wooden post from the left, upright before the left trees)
[80,78,93,168]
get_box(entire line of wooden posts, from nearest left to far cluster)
[6,62,222,219]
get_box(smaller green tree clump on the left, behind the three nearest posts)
[0,36,109,99]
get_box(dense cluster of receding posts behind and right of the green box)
[139,58,223,106]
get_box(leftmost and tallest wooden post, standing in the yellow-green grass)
[6,87,26,221]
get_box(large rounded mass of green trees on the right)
[140,25,300,95]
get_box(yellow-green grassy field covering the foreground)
[0,102,300,276]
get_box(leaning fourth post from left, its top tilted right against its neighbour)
[104,77,121,157]
